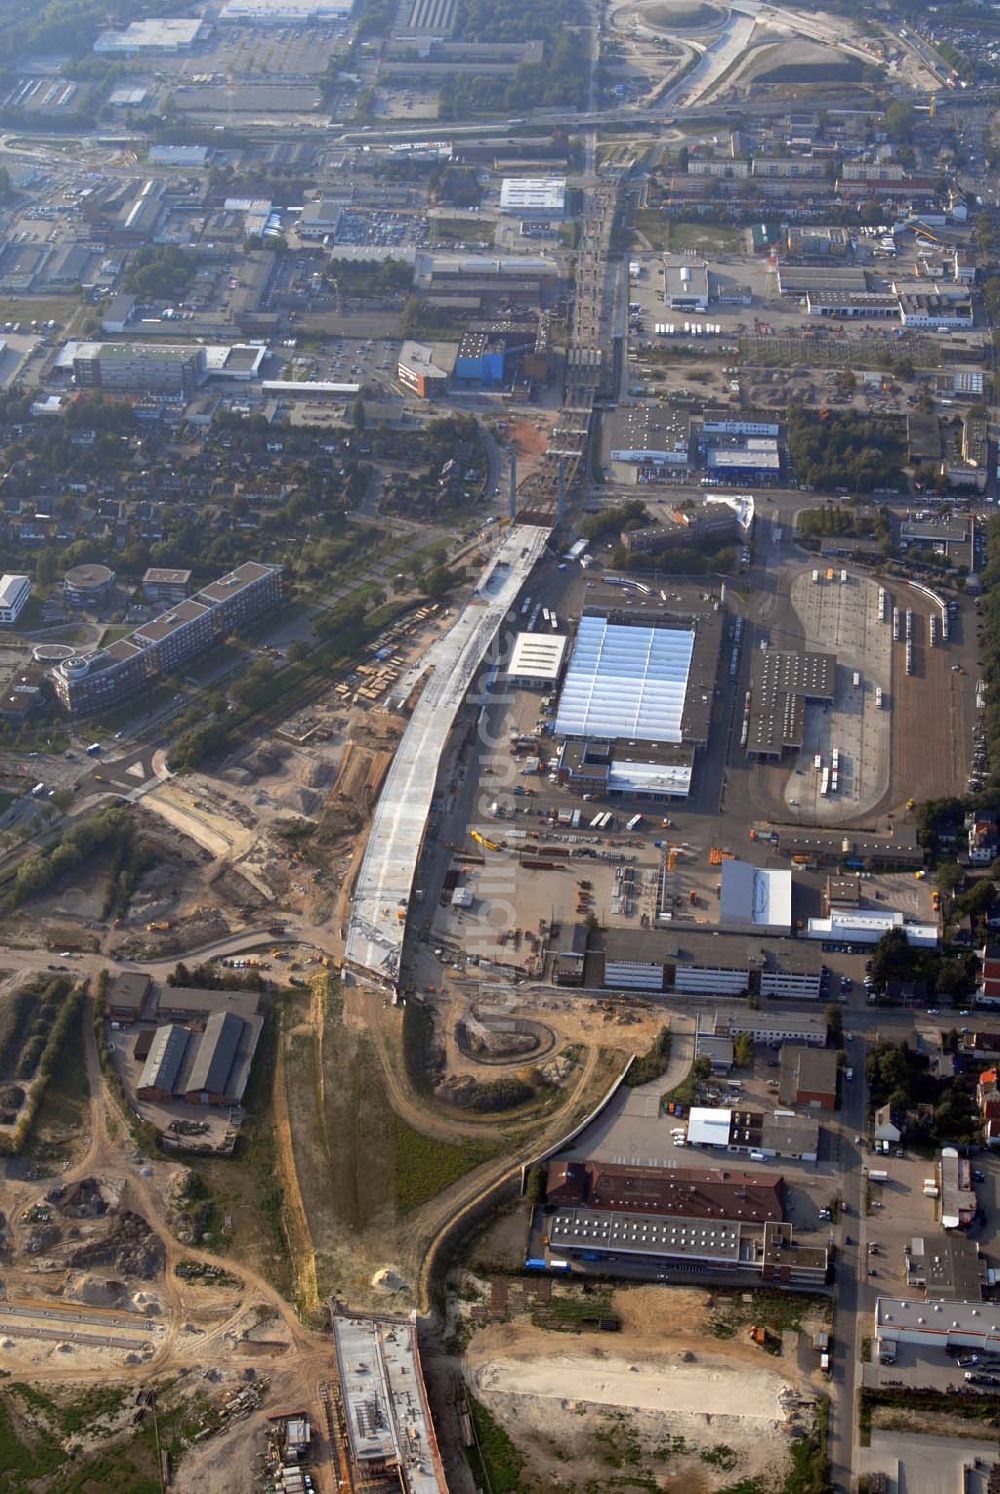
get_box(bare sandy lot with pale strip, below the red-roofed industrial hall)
[465,1320,815,1494]
